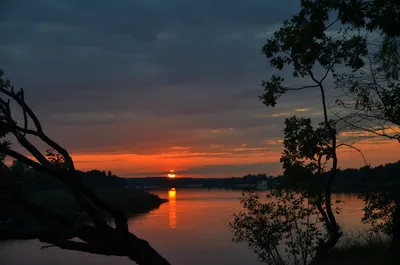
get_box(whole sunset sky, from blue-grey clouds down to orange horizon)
[0,0,400,177]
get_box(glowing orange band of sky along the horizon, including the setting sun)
[6,127,400,178]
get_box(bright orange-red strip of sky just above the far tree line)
[16,135,400,178]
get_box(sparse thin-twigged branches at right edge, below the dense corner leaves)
[335,34,400,142]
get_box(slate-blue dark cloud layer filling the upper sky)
[0,0,295,100]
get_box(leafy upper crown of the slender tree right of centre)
[260,0,367,106]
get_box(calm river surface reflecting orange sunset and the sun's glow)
[0,190,365,265]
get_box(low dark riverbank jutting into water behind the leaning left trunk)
[0,188,168,240]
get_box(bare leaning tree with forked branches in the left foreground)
[0,68,169,265]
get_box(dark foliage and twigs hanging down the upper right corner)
[326,0,400,141]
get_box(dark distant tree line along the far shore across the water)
[125,161,400,194]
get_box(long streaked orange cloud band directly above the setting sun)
[67,148,280,176]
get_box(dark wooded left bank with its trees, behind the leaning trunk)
[0,168,168,240]
